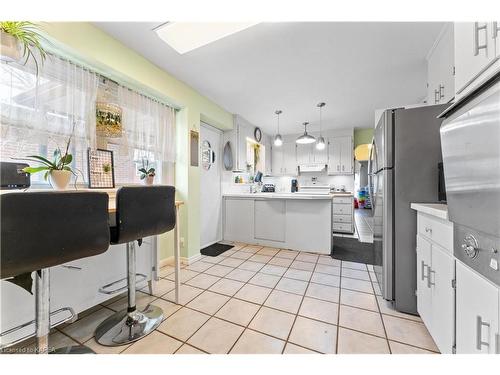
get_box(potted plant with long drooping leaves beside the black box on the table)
[22,137,77,190]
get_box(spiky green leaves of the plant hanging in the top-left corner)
[0,21,47,75]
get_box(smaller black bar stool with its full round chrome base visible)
[95,185,175,346]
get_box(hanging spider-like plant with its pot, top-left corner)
[0,21,47,75]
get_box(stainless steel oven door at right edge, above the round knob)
[440,78,500,237]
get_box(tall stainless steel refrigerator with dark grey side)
[368,105,446,314]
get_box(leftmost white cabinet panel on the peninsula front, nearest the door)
[224,198,254,243]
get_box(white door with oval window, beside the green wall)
[200,123,222,249]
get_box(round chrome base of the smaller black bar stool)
[95,305,163,346]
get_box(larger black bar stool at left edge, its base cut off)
[0,191,109,354]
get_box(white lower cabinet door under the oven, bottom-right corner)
[456,261,500,354]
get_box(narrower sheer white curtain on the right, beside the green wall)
[113,85,175,163]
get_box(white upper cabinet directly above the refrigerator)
[427,23,455,104]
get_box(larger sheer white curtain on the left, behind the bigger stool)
[0,51,98,159]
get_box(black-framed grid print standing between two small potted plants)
[87,148,115,189]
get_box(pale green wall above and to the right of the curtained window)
[42,22,233,258]
